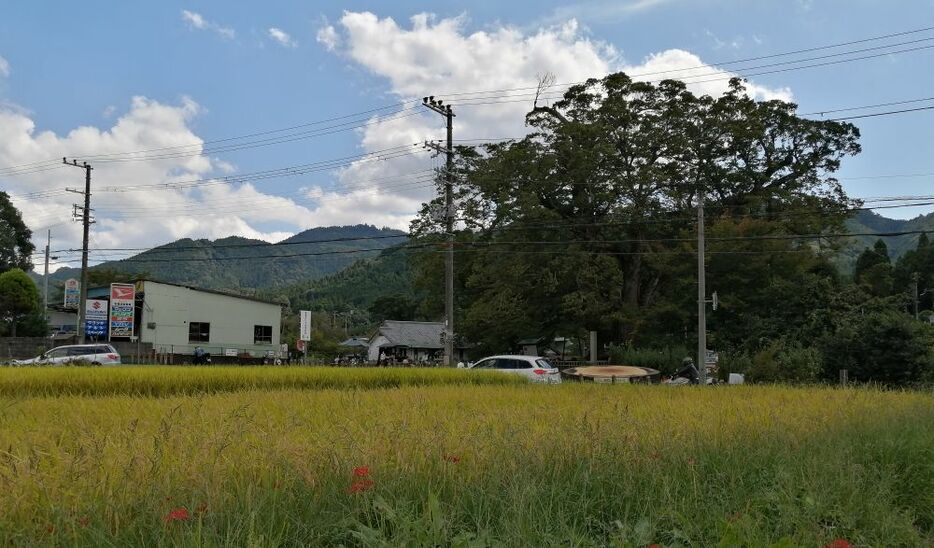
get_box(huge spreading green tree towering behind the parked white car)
[412,73,859,349]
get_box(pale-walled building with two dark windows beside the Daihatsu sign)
[136,280,282,357]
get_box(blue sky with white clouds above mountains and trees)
[0,0,934,268]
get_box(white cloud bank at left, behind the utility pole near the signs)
[0,97,326,259]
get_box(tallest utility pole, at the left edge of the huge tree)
[422,95,454,367]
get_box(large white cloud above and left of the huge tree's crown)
[318,12,791,231]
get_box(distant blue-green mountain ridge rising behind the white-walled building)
[39,225,407,292]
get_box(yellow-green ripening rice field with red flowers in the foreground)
[0,368,934,547]
